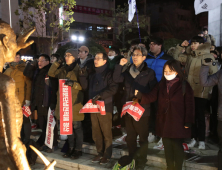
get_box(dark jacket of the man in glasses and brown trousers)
[79,64,118,113]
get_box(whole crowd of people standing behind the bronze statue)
[4,26,222,170]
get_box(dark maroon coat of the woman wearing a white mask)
[141,79,194,138]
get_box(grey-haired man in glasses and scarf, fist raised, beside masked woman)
[113,46,157,169]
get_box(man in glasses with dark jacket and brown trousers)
[79,53,118,164]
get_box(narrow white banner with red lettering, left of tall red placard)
[45,108,56,149]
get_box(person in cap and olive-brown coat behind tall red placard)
[48,49,84,159]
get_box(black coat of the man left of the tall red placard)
[23,63,58,115]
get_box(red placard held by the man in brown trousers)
[79,99,106,115]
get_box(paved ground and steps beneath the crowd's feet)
[29,128,218,170]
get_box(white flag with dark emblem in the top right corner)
[194,0,222,15]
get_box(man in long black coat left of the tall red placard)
[23,54,58,152]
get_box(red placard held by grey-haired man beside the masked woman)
[121,101,145,121]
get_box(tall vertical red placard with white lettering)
[59,79,72,135]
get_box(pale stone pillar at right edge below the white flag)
[208,4,222,46]
